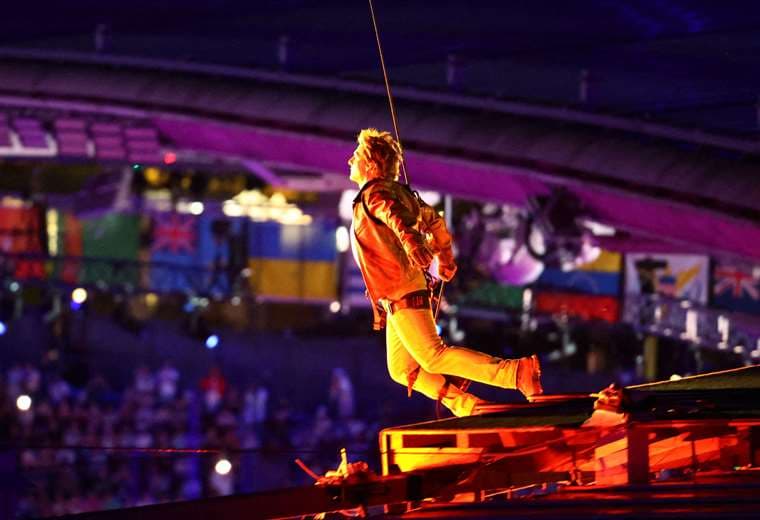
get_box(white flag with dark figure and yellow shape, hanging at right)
[625,253,708,304]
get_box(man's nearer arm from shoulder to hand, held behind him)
[364,185,433,269]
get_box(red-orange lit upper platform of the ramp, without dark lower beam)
[380,366,760,508]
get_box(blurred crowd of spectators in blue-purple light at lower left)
[0,362,378,518]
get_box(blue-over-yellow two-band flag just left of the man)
[248,220,338,302]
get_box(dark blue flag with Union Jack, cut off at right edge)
[712,262,760,314]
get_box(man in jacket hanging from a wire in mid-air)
[348,128,543,416]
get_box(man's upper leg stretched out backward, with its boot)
[388,309,542,395]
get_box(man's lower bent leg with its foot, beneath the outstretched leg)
[385,322,481,417]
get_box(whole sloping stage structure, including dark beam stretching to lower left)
[63,366,760,520]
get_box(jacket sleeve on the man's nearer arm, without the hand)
[364,185,425,252]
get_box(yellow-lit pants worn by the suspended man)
[386,309,518,417]
